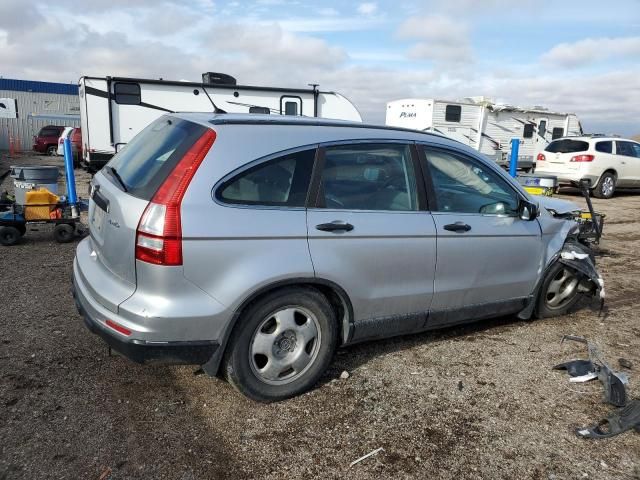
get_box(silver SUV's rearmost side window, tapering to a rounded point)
[217,149,316,207]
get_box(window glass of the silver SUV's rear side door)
[319,144,418,211]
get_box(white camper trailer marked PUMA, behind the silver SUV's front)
[386,97,582,170]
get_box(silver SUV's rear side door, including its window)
[307,142,436,338]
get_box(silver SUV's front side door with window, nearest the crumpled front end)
[422,146,543,326]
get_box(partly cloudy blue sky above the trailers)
[0,0,640,135]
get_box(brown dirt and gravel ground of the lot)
[0,157,640,480]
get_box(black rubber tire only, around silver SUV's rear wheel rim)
[222,287,338,402]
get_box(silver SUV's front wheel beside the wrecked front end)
[536,262,580,318]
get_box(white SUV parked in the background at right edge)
[536,136,640,198]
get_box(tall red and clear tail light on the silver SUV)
[136,129,216,266]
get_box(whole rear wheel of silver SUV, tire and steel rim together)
[223,288,338,402]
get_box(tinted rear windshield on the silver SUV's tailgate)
[104,117,206,200]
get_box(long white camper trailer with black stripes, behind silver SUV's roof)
[78,72,362,170]
